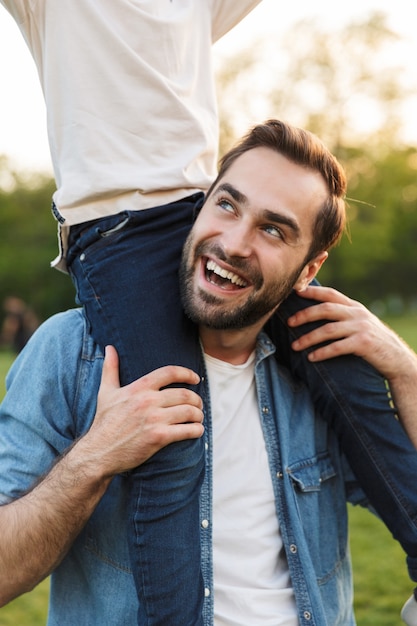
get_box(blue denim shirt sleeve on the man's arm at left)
[0,310,88,504]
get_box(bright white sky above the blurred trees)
[0,0,417,172]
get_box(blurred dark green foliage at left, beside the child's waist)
[0,157,74,319]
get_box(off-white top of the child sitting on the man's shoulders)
[0,0,261,264]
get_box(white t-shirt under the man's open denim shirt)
[205,355,299,626]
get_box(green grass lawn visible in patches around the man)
[0,316,417,626]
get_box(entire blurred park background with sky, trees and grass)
[0,0,417,626]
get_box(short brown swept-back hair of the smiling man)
[207,119,347,260]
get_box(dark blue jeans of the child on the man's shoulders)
[68,195,417,626]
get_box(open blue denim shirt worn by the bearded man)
[0,309,363,626]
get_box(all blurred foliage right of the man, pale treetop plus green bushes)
[217,11,417,315]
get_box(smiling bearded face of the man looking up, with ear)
[181,147,328,338]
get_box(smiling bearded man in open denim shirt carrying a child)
[0,120,417,626]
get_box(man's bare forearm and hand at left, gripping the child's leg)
[0,349,204,606]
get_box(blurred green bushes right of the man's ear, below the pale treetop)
[320,142,417,314]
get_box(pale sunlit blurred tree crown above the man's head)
[217,12,416,157]
